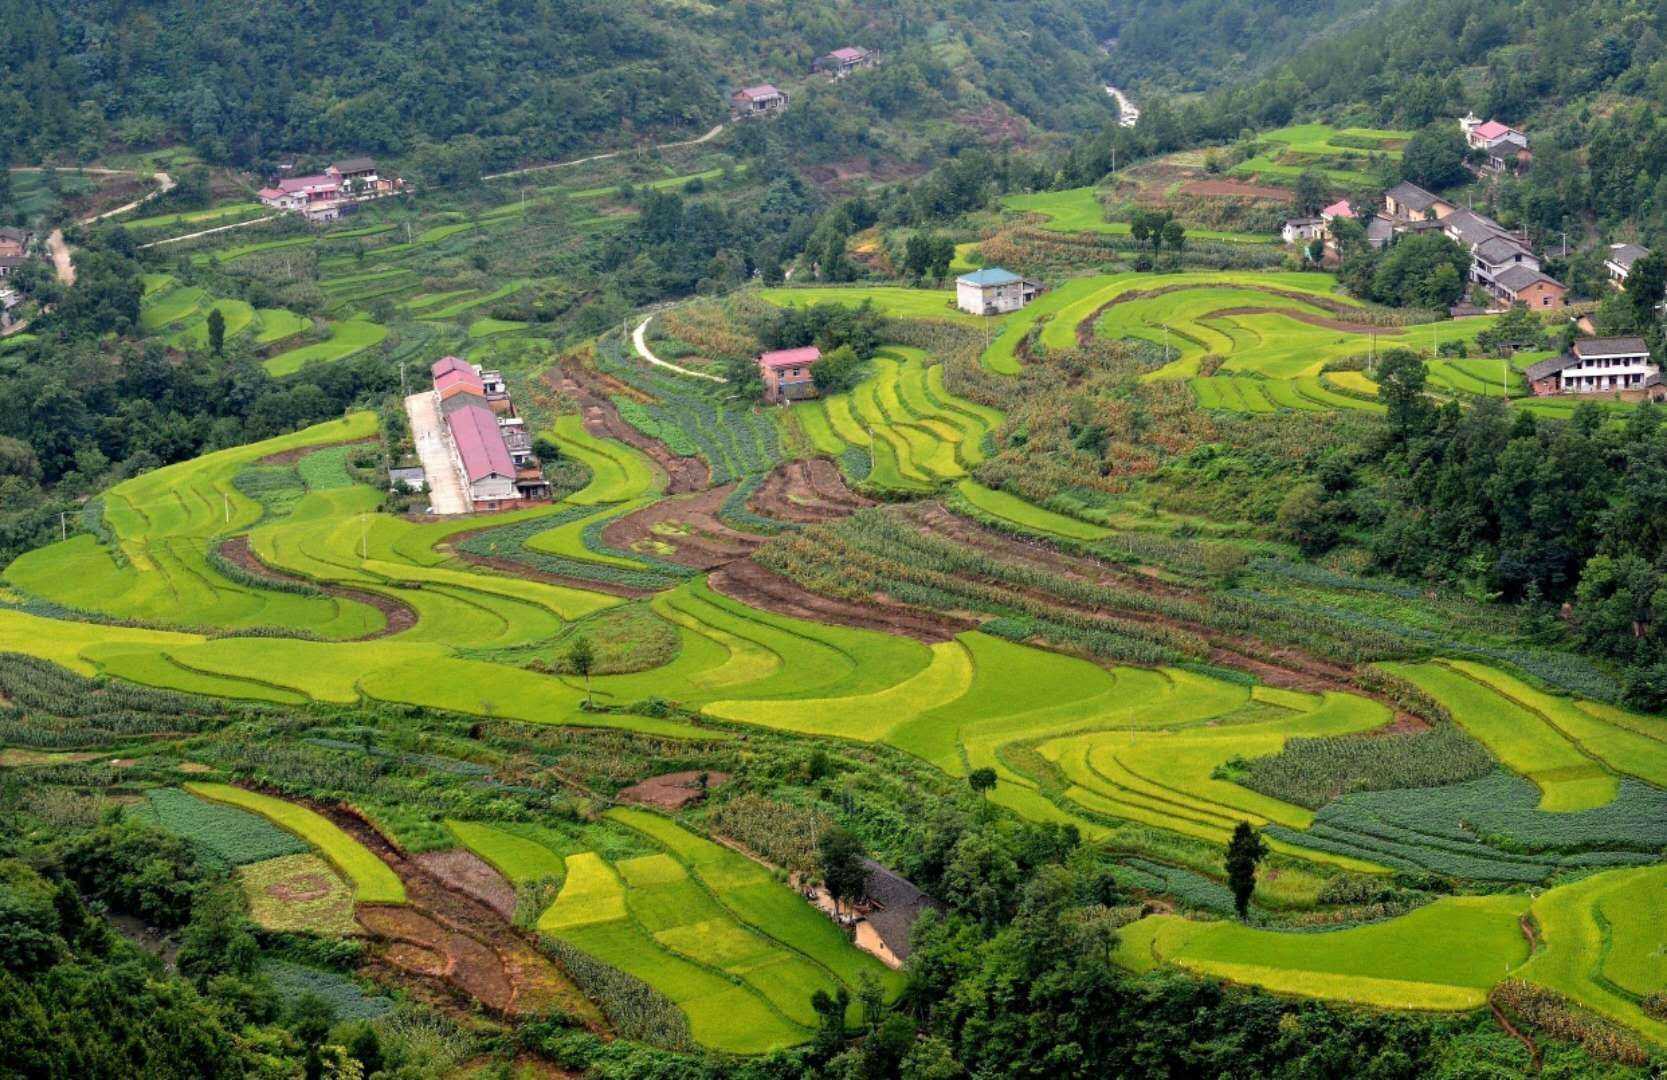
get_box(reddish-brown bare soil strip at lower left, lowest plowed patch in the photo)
[315,805,603,1030]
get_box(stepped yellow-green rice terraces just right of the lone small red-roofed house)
[792,345,1002,493]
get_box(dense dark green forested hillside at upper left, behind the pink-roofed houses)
[0,0,1105,167]
